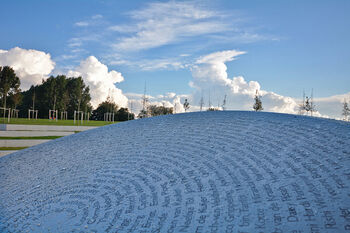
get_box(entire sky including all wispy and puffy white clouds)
[0,0,350,118]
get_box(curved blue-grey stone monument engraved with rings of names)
[0,112,350,233]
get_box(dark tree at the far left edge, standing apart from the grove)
[0,66,21,117]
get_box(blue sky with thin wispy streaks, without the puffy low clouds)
[0,0,350,116]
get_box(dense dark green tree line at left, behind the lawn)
[0,66,134,121]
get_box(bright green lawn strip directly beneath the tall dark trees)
[0,118,118,126]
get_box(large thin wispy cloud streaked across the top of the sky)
[109,1,232,51]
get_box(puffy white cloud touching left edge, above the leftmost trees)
[0,47,55,90]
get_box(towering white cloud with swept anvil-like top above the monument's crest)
[190,50,298,113]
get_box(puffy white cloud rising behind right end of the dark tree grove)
[68,56,128,108]
